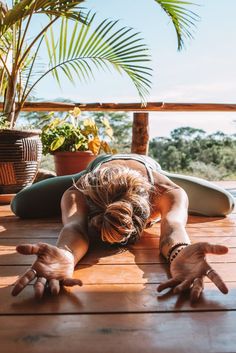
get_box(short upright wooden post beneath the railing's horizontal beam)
[131,113,149,154]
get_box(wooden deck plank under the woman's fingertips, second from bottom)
[0,282,236,315]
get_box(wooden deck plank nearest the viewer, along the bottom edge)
[0,311,236,353]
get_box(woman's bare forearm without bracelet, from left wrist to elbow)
[56,223,89,265]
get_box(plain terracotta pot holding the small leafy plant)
[53,151,96,176]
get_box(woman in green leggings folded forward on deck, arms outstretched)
[12,154,234,301]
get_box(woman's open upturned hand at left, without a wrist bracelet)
[12,243,82,299]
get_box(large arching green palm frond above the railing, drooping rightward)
[42,15,151,102]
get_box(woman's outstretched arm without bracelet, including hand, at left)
[12,190,89,298]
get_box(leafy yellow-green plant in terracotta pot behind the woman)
[41,108,115,175]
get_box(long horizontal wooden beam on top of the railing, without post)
[0,102,236,112]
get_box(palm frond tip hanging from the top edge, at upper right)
[155,0,199,50]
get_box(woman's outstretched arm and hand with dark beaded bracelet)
[155,188,228,301]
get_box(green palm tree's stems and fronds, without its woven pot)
[0,0,196,128]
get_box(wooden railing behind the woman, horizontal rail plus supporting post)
[0,102,236,154]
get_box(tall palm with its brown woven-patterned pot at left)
[0,0,196,194]
